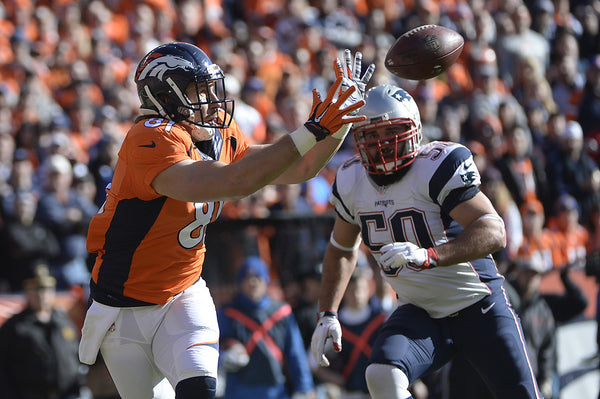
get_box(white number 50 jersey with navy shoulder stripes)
[330,141,502,318]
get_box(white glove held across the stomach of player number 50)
[379,242,437,272]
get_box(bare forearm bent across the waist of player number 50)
[435,219,506,266]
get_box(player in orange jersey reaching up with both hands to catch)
[79,42,374,399]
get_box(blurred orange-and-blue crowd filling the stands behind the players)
[0,0,600,398]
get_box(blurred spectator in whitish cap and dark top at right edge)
[546,121,600,220]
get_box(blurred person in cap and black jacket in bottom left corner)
[0,265,84,399]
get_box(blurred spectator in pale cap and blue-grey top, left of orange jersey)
[36,155,98,289]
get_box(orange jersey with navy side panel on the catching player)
[87,118,248,306]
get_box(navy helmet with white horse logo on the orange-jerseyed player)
[135,42,234,128]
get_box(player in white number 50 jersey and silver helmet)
[311,85,541,399]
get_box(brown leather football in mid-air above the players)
[385,25,465,80]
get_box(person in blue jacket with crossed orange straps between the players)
[217,256,314,399]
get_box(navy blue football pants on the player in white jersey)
[369,279,542,399]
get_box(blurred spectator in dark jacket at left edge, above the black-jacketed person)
[0,191,60,292]
